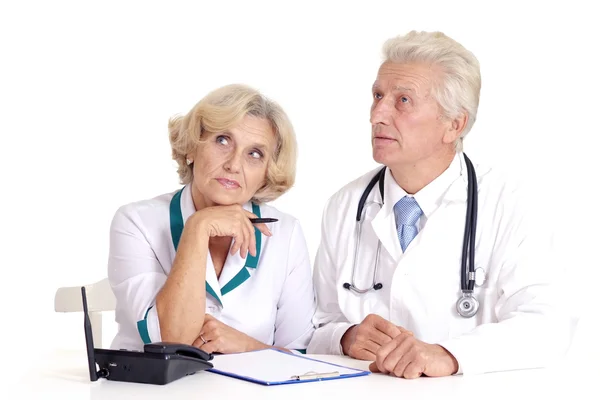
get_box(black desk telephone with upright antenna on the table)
[81,287,213,385]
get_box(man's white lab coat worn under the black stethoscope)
[308,153,570,374]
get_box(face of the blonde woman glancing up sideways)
[188,116,277,210]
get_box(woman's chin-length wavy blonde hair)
[168,84,297,203]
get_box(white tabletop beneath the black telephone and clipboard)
[7,350,600,400]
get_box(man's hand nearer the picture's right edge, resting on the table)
[369,333,458,379]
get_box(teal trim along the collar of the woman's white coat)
[169,188,262,305]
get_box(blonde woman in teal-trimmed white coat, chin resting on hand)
[108,85,315,353]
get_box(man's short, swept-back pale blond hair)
[383,31,481,151]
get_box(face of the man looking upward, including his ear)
[371,62,459,168]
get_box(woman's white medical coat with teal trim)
[108,185,315,351]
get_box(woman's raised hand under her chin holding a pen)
[192,204,271,258]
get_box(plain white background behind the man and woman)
[0,0,600,378]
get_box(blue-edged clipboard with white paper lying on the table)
[206,348,371,386]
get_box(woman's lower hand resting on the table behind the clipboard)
[192,314,270,354]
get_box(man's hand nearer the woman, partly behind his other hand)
[341,314,412,361]
